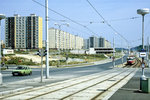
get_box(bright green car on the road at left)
[12,66,32,76]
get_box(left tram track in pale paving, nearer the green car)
[0,68,135,100]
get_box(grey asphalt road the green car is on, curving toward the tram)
[2,56,127,83]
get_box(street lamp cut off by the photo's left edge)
[0,14,5,85]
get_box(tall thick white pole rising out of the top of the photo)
[45,0,49,79]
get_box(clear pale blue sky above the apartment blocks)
[0,0,150,48]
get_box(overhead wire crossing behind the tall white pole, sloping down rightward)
[32,0,98,35]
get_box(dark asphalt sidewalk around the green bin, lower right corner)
[109,68,150,100]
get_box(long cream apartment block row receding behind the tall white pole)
[48,28,83,50]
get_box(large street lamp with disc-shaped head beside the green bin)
[137,8,149,89]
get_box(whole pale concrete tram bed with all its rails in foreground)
[0,68,137,100]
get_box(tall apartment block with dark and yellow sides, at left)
[5,14,43,49]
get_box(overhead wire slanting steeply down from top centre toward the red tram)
[86,0,129,44]
